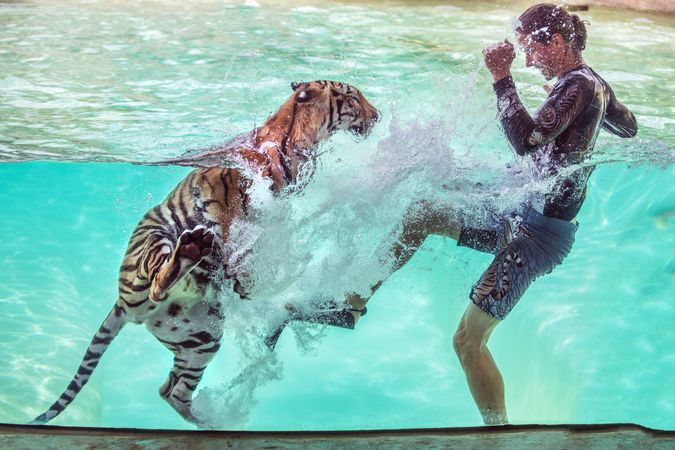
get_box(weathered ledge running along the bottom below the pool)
[0,424,675,450]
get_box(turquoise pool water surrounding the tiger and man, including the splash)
[0,0,675,429]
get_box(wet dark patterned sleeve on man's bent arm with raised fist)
[494,76,592,156]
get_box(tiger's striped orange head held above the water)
[291,80,380,138]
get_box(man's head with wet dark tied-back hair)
[515,3,586,80]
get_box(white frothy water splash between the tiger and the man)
[187,75,572,428]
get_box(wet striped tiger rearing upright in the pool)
[31,80,379,426]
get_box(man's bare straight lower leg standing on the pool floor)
[453,303,508,425]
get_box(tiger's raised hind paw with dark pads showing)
[150,225,215,302]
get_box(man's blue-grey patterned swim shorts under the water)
[457,208,577,320]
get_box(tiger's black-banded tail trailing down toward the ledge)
[30,304,126,425]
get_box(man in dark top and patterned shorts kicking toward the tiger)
[267,4,637,424]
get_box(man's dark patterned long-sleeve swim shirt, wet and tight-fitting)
[494,65,637,220]
